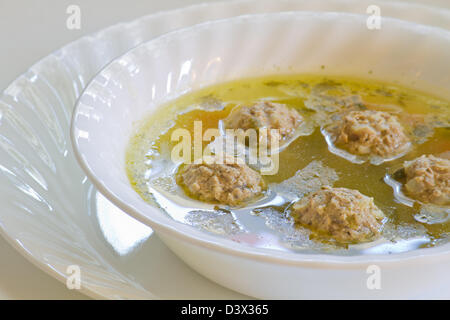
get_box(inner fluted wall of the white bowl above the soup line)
[71,12,450,259]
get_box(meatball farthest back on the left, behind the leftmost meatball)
[224,102,303,144]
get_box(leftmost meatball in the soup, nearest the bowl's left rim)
[179,157,264,205]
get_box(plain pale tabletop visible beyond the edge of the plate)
[0,0,450,299]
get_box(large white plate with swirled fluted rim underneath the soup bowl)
[0,0,450,299]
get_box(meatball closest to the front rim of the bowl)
[292,187,385,243]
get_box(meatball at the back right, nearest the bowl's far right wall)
[331,110,409,158]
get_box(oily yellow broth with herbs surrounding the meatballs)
[126,75,450,255]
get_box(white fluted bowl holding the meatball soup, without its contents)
[71,12,450,298]
